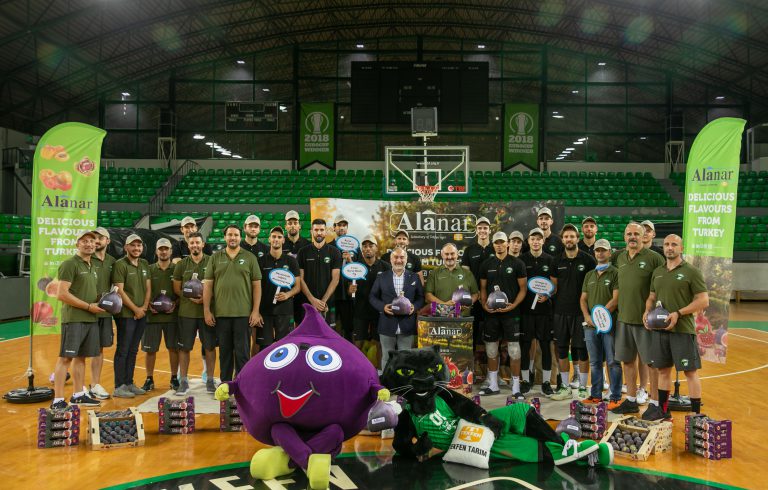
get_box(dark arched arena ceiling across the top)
[0,0,768,130]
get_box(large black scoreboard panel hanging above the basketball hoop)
[352,61,488,125]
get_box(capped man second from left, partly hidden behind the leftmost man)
[90,226,115,400]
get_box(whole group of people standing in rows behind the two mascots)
[52,208,708,420]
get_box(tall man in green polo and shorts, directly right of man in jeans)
[613,222,664,414]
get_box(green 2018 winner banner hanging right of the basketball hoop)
[501,104,539,171]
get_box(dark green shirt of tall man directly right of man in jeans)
[614,248,664,325]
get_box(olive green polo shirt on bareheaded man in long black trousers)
[205,248,261,317]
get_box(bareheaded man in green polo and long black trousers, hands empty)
[203,225,263,382]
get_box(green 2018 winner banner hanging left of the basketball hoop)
[299,102,336,170]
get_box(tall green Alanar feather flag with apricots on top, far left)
[30,123,107,335]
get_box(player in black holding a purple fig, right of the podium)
[479,231,530,400]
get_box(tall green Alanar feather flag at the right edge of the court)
[683,117,746,363]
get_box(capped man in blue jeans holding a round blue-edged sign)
[579,239,621,410]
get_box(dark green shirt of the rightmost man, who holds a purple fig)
[651,261,707,334]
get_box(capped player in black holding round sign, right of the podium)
[520,228,553,396]
